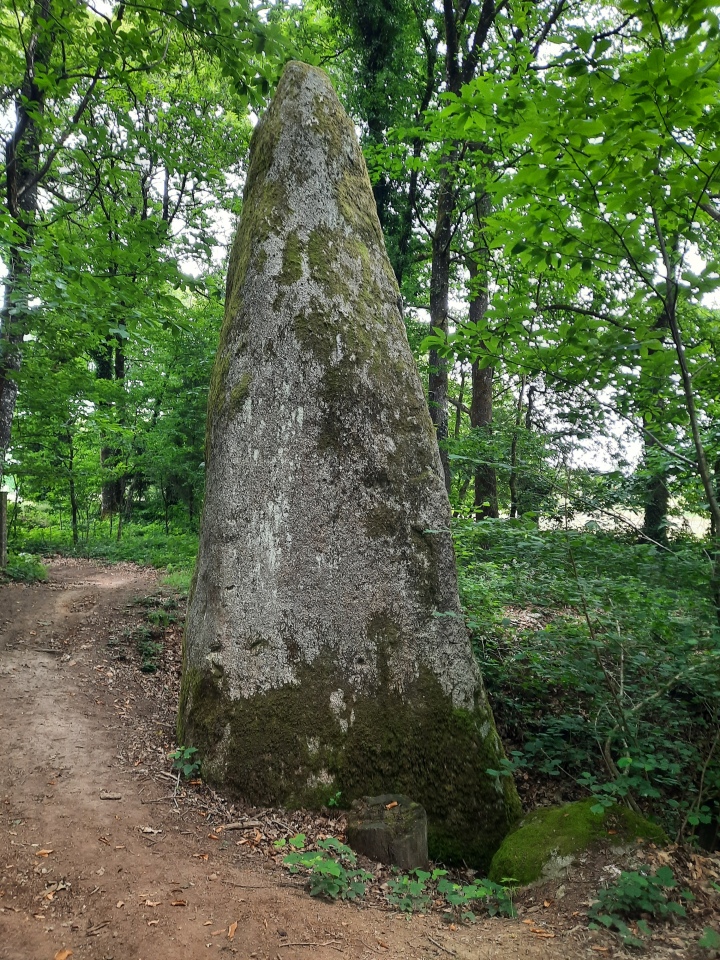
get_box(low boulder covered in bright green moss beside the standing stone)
[489,800,667,886]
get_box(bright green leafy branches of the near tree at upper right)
[424,3,718,584]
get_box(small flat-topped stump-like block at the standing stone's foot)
[347,793,428,870]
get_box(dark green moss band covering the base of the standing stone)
[179,652,520,869]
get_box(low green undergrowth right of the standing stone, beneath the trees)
[456,520,720,846]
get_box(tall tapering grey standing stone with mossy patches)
[178,63,520,866]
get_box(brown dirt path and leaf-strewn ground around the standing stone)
[0,560,717,960]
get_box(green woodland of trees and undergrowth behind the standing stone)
[0,0,720,848]
